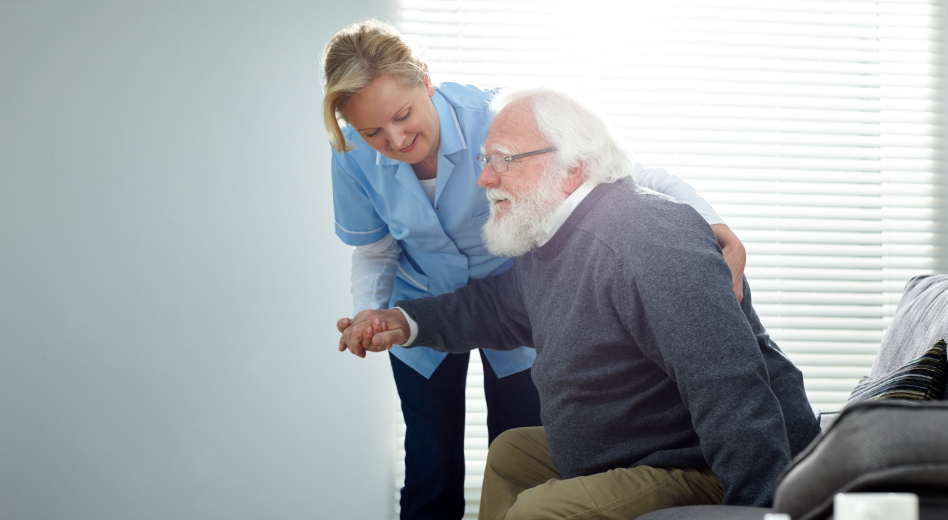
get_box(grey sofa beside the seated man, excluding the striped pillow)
[639,275,948,520]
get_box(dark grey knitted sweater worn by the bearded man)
[397,178,819,506]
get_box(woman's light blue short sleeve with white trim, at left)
[332,151,388,246]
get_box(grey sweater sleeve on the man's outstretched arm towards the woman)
[395,264,533,353]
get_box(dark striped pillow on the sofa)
[846,339,948,404]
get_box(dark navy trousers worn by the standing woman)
[389,351,540,520]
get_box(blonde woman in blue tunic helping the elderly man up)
[323,20,744,519]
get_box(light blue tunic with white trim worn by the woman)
[332,83,536,378]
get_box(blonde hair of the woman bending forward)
[322,20,427,152]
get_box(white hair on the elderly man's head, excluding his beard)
[490,87,632,183]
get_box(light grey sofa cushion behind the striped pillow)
[869,274,948,379]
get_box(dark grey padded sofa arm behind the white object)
[774,400,948,520]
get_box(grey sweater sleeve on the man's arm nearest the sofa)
[617,208,790,506]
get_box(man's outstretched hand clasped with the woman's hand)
[336,309,411,358]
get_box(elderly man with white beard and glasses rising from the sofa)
[337,89,819,520]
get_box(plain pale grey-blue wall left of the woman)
[0,0,395,520]
